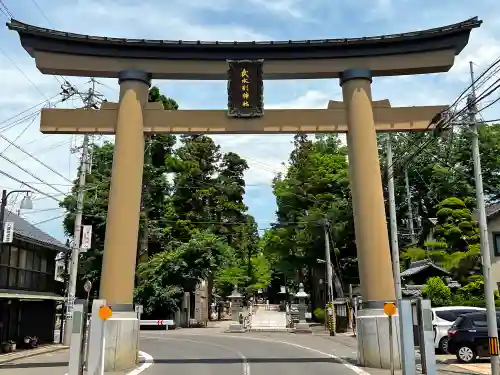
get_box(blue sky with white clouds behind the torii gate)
[0,0,500,244]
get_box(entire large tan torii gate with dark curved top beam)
[8,18,481,369]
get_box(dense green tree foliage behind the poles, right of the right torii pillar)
[388,124,500,251]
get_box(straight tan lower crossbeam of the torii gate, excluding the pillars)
[40,100,447,134]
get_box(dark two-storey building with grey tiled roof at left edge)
[0,212,67,344]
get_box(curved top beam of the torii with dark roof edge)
[7,17,482,80]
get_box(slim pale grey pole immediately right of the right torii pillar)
[387,134,403,300]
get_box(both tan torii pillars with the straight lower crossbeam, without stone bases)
[40,69,447,308]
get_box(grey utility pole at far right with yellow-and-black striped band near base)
[467,61,500,375]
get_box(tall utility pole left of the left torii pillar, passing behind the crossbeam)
[63,79,96,346]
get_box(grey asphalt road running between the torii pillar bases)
[141,333,355,375]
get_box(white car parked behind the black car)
[432,306,486,353]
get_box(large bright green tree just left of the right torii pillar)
[264,135,357,302]
